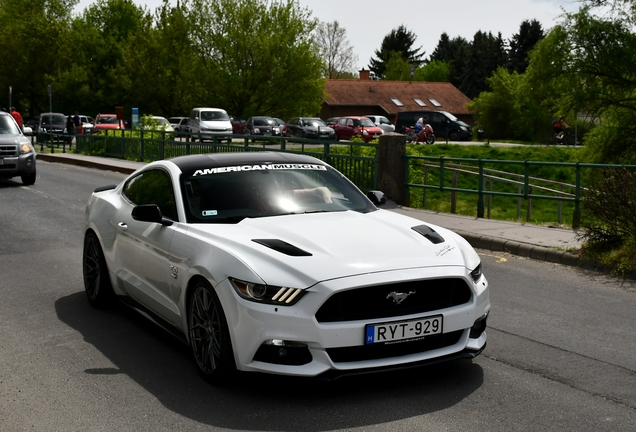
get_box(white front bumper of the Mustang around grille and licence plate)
[216,267,490,377]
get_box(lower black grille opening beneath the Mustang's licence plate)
[327,330,464,363]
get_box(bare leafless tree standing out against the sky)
[314,21,358,79]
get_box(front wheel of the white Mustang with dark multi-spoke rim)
[187,280,236,384]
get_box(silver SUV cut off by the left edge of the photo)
[0,112,35,185]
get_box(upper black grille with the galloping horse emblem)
[316,278,472,323]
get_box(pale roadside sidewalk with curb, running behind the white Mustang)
[37,153,581,266]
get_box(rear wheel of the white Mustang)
[82,231,114,309]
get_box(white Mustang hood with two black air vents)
[189,210,479,287]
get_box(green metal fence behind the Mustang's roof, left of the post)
[69,130,378,191]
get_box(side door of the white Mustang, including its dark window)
[114,168,179,322]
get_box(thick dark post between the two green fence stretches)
[378,132,410,206]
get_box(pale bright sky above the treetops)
[76,0,580,70]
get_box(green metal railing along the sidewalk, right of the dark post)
[405,155,636,228]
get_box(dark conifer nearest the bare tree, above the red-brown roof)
[369,25,425,78]
